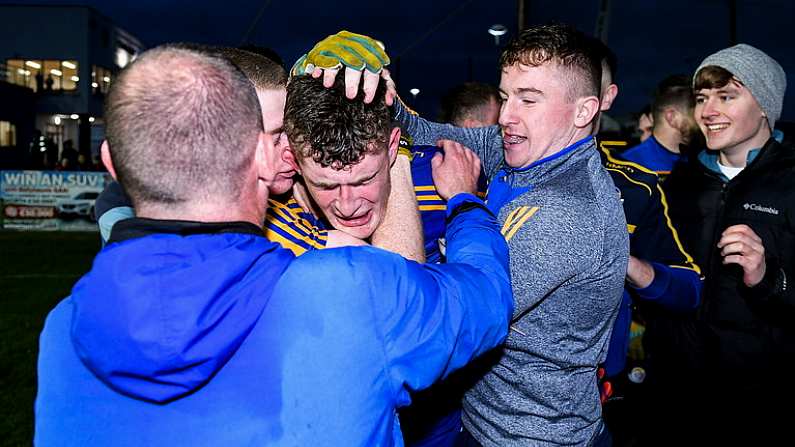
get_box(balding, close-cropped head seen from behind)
[105,45,262,208]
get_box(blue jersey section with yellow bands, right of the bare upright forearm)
[414,142,486,262]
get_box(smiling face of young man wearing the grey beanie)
[695,80,770,153]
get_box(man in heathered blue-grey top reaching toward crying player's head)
[296,24,629,446]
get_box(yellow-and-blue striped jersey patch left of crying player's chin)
[264,197,328,256]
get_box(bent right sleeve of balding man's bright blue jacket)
[376,194,513,390]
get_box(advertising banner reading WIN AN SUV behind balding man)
[0,171,111,231]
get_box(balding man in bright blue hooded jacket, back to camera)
[35,46,513,446]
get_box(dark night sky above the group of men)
[0,0,795,121]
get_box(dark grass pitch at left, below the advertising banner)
[0,231,100,446]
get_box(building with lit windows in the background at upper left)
[0,5,143,166]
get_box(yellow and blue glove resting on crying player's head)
[290,31,390,76]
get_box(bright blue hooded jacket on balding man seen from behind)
[35,195,513,446]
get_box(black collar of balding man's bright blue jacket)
[108,217,264,243]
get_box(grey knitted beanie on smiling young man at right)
[693,43,787,130]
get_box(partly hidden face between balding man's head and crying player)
[257,88,295,195]
